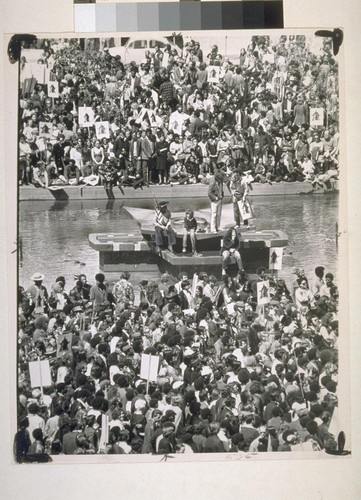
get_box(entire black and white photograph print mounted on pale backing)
[14,29,350,463]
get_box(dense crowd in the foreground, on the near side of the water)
[15,266,338,461]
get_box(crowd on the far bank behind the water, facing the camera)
[19,36,339,191]
